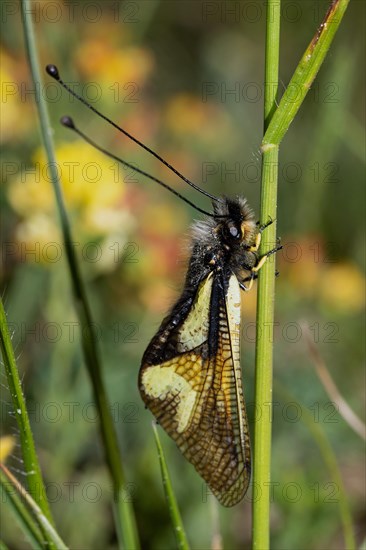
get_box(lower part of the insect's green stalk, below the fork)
[252,147,278,550]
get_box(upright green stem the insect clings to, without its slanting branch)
[252,0,281,550]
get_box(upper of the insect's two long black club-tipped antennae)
[46,65,221,202]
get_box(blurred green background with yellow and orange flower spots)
[1,0,365,549]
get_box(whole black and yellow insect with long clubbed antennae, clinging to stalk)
[46,65,281,506]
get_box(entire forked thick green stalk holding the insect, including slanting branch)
[253,0,349,550]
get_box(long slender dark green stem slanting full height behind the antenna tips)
[21,0,139,549]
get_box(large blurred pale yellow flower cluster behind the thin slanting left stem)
[8,141,134,271]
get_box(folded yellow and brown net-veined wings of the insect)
[140,273,250,506]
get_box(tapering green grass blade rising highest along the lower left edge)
[0,299,53,523]
